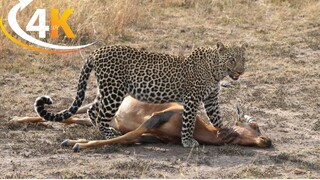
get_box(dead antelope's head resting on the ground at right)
[232,106,272,148]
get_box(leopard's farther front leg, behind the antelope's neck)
[203,85,222,128]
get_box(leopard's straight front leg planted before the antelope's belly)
[181,98,199,147]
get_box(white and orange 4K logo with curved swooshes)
[0,0,93,54]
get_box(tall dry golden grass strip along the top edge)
[0,0,320,45]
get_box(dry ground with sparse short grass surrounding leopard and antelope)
[0,0,320,178]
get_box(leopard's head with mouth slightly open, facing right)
[217,42,248,80]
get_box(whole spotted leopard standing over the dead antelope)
[34,41,248,147]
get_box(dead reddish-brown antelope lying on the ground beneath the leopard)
[11,96,272,152]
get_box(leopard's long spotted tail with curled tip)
[34,56,93,122]
